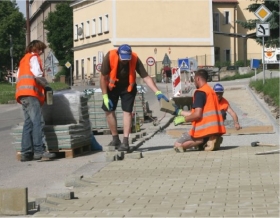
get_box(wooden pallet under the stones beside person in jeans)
[16,145,91,160]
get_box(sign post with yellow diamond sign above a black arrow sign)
[254,5,272,84]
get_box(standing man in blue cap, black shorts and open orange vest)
[100,44,168,151]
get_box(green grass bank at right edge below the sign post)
[249,77,280,106]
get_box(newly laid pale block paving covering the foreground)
[34,83,279,217]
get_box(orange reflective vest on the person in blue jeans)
[16,53,45,105]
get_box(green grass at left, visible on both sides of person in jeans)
[0,82,69,104]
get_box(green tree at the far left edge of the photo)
[0,0,26,71]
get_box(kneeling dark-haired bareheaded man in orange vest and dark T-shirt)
[174,69,226,152]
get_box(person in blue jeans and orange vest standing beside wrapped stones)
[16,40,55,161]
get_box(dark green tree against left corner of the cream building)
[44,1,74,70]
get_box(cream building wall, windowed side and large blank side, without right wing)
[72,0,214,83]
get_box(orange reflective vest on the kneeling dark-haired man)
[189,84,226,138]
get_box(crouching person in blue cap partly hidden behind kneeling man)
[213,83,241,130]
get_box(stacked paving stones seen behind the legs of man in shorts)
[88,86,145,130]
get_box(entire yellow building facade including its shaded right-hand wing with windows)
[71,0,261,82]
